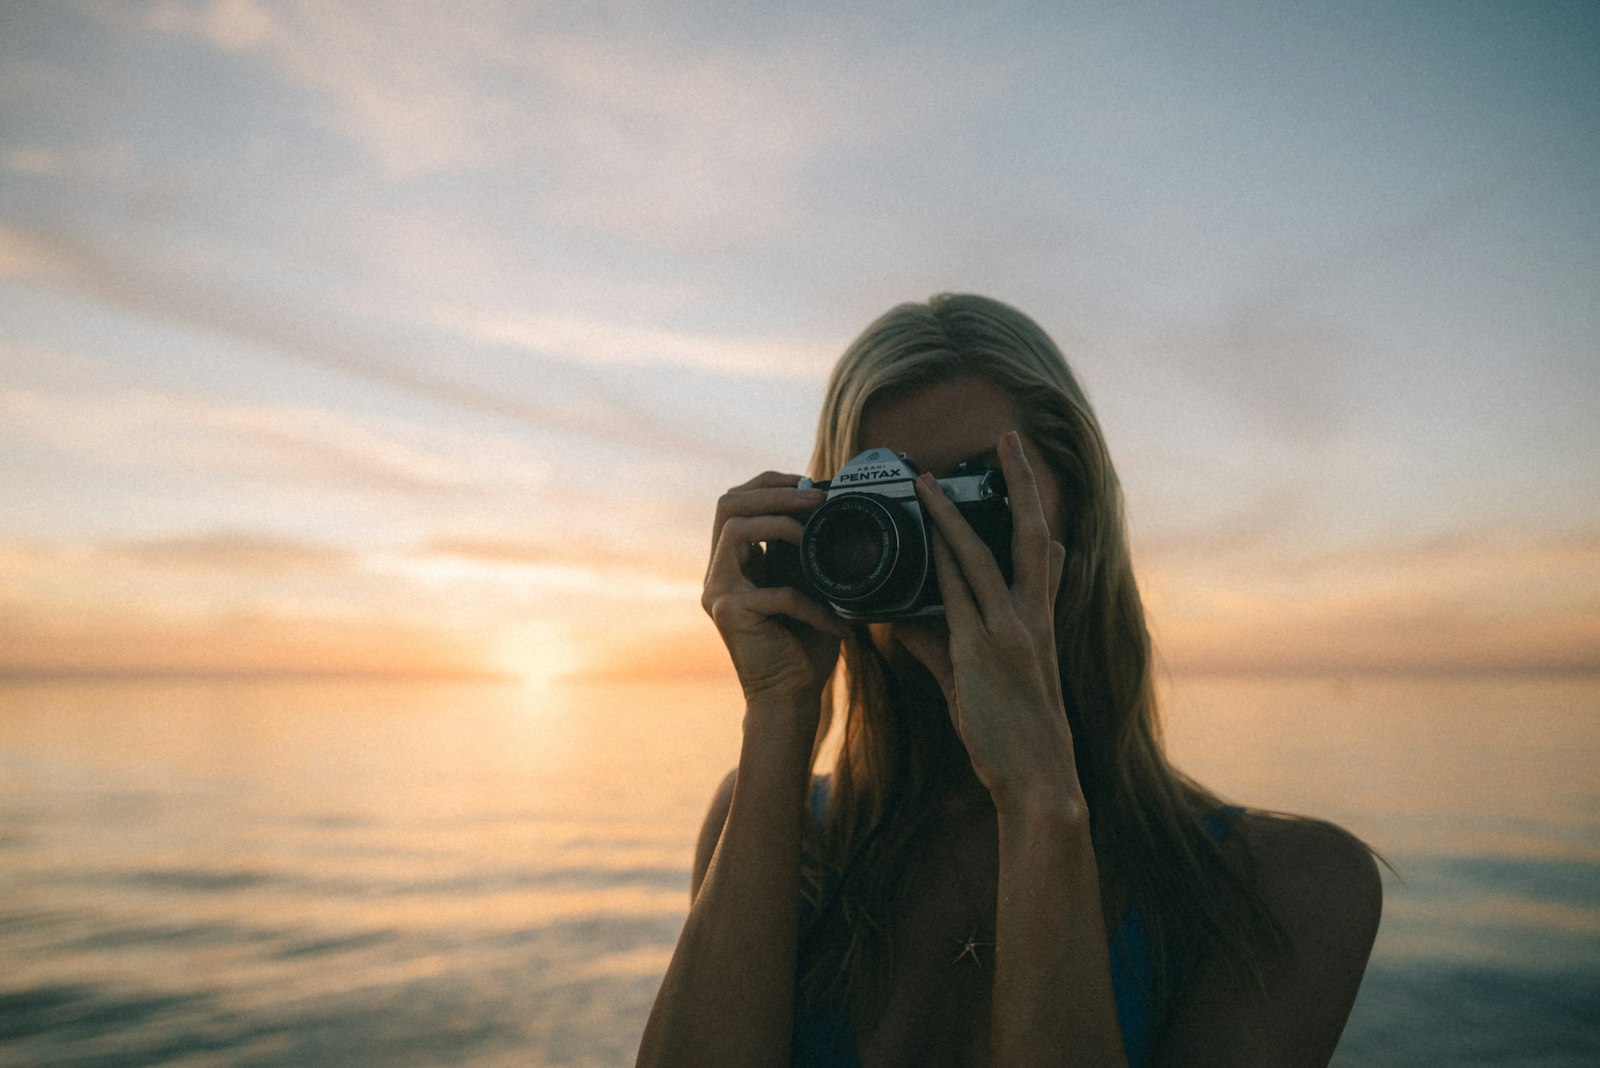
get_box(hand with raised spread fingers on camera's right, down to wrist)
[896,432,1083,811]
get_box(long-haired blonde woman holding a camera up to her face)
[638,296,1381,1068]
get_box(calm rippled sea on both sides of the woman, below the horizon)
[0,678,1600,1066]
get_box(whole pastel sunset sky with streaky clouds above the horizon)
[0,0,1600,681]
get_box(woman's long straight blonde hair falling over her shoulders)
[800,294,1270,1025]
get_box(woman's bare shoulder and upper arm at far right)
[1160,812,1382,1068]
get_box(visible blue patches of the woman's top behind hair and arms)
[790,779,1242,1068]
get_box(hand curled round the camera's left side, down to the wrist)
[701,472,850,702]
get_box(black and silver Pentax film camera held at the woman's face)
[763,449,1011,622]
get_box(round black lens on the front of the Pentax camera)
[800,494,926,608]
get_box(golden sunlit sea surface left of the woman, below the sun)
[0,683,738,1065]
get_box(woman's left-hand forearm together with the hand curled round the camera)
[638,473,850,1065]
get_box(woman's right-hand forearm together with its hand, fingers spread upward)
[901,433,1126,1068]
